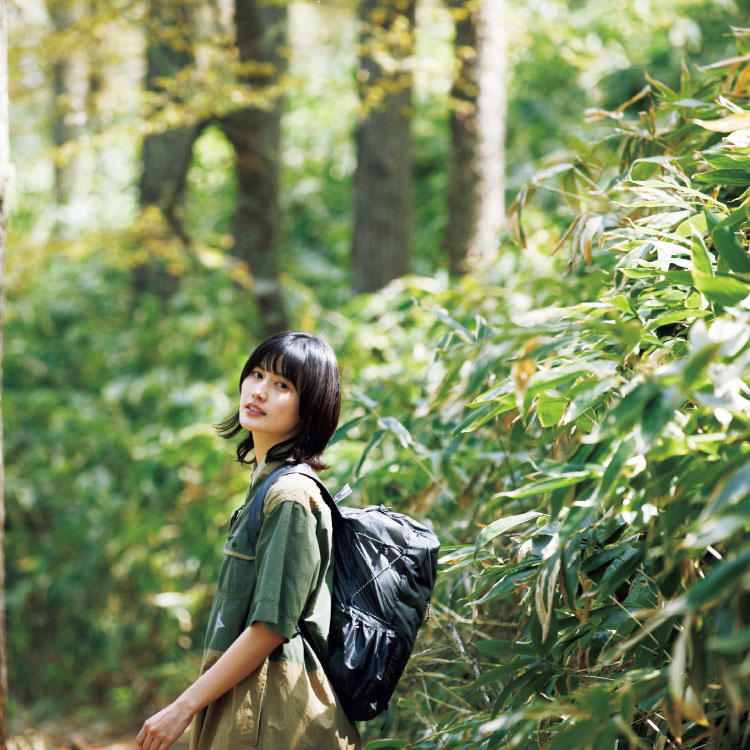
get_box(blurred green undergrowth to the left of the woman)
[4,255,260,720]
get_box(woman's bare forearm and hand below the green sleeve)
[136,622,285,750]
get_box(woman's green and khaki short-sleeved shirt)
[190,462,360,750]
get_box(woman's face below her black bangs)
[239,367,300,445]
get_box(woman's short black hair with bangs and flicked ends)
[216,331,341,470]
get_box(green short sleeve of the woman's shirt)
[247,501,321,640]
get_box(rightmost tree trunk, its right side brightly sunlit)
[443,0,507,275]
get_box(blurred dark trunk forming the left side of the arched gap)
[134,0,204,294]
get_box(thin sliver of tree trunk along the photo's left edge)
[0,0,10,750]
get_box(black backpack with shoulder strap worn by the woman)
[247,464,440,721]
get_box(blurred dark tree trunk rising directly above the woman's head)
[222,0,288,335]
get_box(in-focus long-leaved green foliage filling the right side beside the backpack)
[338,36,750,750]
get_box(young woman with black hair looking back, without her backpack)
[136,331,361,750]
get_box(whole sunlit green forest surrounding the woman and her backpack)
[0,0,750,750]
